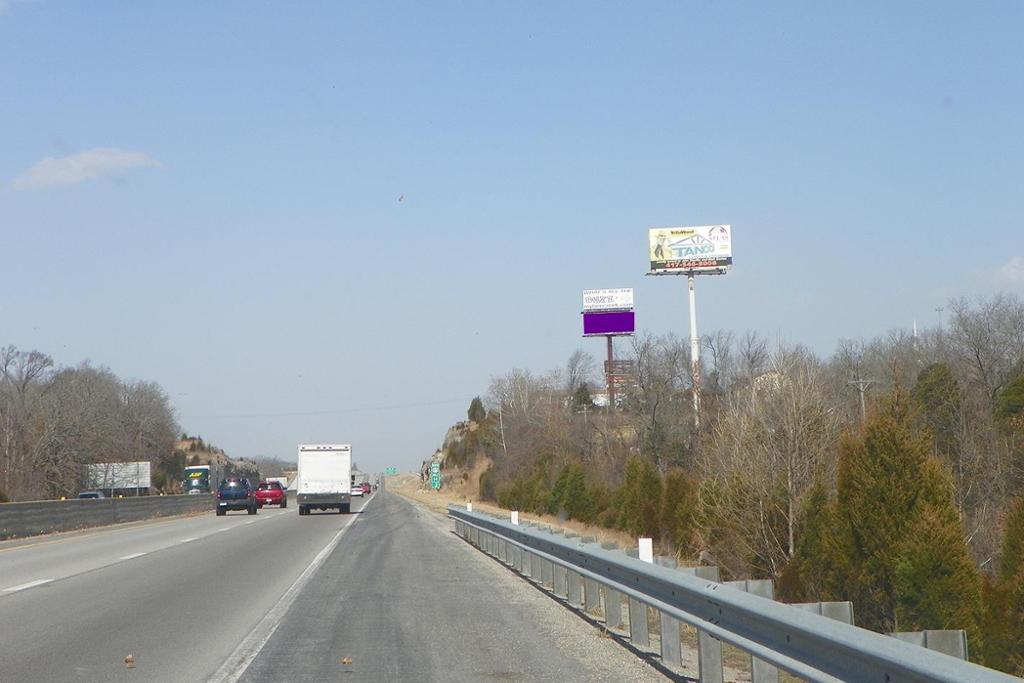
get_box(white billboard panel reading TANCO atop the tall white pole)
[648,225,732,273]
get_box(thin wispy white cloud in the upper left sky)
[9,148,163,190]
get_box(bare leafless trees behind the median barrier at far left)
[0,346,184,501]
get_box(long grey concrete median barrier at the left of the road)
[0,494,214,540]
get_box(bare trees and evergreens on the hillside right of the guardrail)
[443,294,1024,674]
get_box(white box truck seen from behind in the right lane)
[296,443,352,515]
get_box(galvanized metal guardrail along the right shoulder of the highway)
[449,506,1022,683]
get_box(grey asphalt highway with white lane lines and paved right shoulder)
[0,492,662,683]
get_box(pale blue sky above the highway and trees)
[0,0,1024,469]
